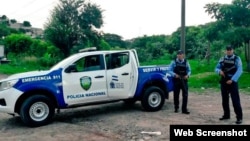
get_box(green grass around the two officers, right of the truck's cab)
[143,57,250,94]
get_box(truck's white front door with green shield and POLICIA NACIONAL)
[63,54,108,105]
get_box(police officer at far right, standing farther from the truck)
[215,46,243,124]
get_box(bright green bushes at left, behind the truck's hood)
[4,34,62,67]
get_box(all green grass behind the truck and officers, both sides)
[0,59,250,93]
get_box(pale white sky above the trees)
[0,0,232,39]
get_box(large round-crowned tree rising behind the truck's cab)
[44,0,103,57]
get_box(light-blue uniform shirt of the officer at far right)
[215,55,243,82]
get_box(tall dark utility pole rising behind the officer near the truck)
[181,0,186,54]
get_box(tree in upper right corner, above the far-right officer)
[205,0,250,71]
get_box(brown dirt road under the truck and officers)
[0,82,250,141]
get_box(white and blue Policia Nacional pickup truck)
[0,49,173,127]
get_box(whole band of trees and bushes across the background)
[0,0,250,83]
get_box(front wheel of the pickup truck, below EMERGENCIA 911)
[20,95,55,127]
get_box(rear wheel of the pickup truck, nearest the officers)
[141,86,165,112]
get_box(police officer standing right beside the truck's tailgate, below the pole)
[170,50,191,114]
